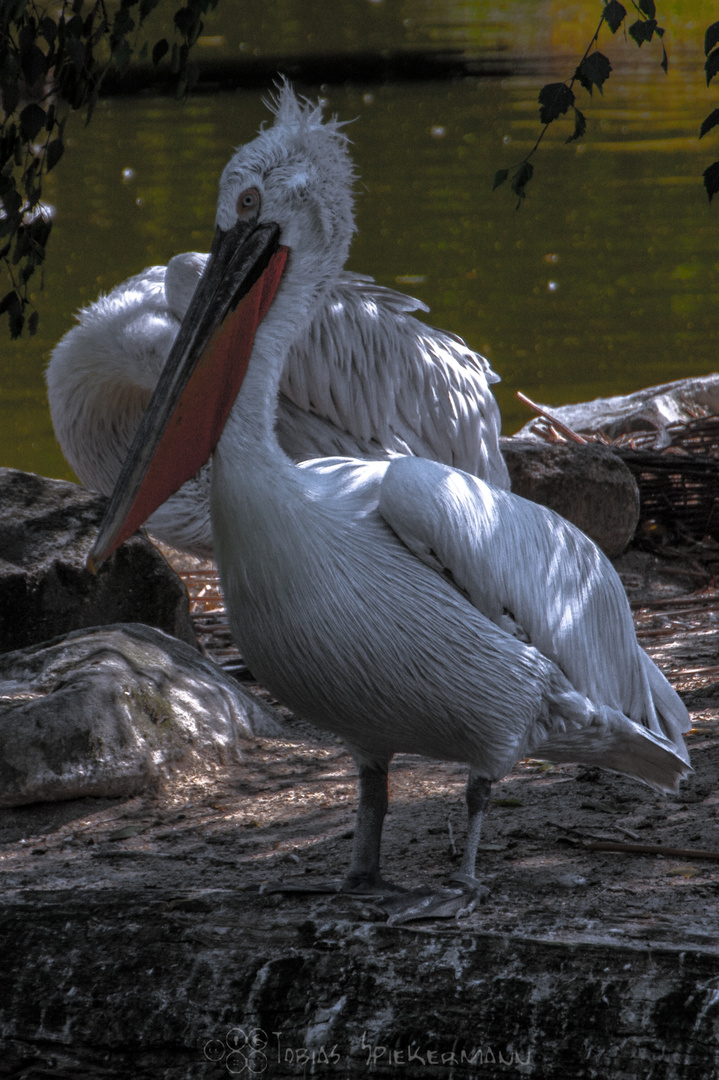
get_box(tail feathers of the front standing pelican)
[532,704,693,792]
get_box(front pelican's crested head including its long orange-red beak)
[87,82,355,570]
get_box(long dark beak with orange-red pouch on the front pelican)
[86,222,287,572]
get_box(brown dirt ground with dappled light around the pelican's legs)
[0,546,719,948]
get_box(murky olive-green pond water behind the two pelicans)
[0,0,719,477]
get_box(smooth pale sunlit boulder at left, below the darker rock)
[0,623,280,807]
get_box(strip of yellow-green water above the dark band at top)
[175,0,716,66]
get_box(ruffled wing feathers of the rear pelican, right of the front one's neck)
[280,272,508,487]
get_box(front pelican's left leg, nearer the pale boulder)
[341,765,402,893]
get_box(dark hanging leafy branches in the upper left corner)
[0,0,217,338]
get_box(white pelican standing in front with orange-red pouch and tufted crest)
[89,86,691,911]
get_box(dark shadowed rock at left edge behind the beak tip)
[0,469,196,651]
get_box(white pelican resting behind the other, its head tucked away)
[46,196,510,557]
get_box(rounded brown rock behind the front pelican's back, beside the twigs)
[500,436,639,558]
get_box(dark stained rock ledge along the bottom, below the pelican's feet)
[0,889,719,1080]
